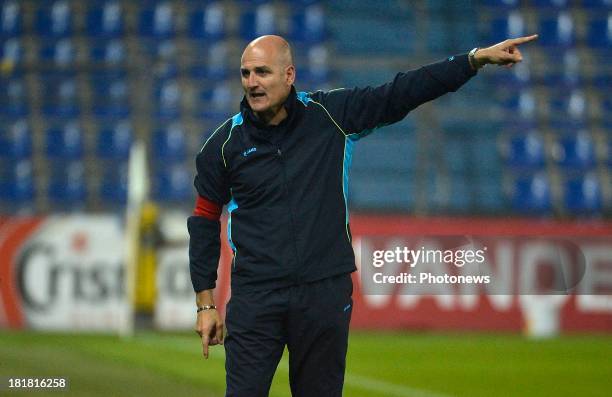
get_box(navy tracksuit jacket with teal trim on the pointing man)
[188,54,476,292]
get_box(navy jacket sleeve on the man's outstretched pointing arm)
[312,54,476,135]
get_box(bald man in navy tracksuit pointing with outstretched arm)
[188,35,536,397]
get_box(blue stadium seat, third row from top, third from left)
[92,75,131,118]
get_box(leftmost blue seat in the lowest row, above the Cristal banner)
[0,160,36,206]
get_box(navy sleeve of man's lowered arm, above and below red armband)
[187,127,230,292]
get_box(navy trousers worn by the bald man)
[225,274,353,397]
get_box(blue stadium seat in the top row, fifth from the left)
[188,1,227,42]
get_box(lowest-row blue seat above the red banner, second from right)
[512,172,552,214]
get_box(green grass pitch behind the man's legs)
[0,331,612,397]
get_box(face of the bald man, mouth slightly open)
[240,47,295,114]
